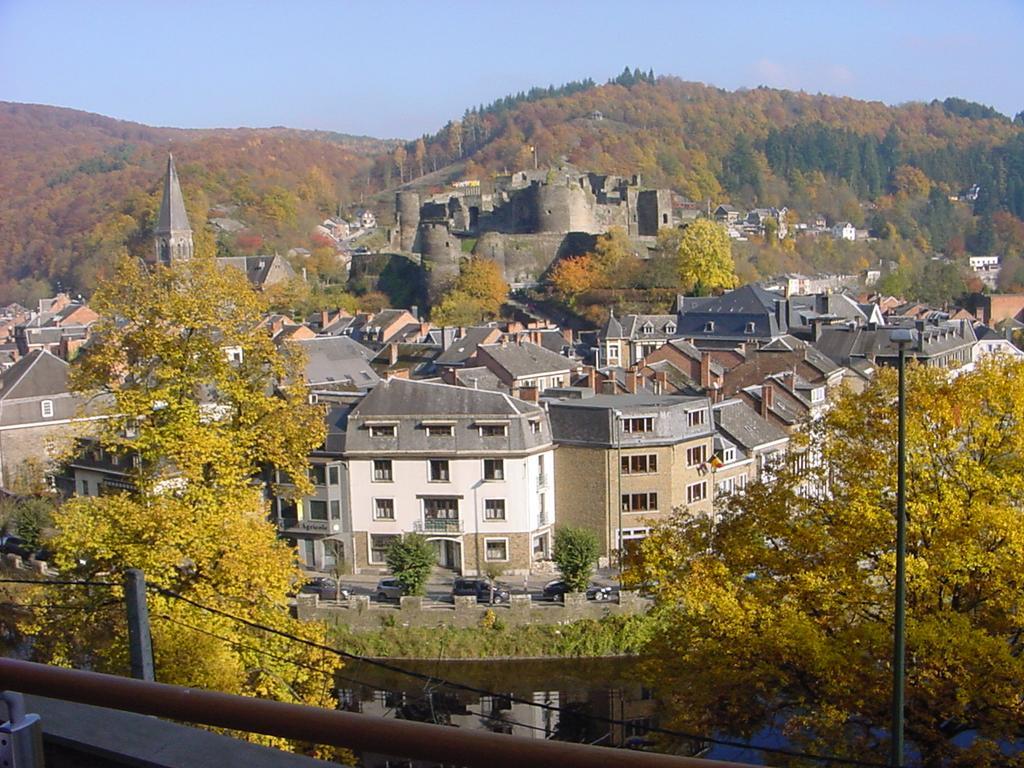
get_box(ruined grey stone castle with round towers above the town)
[391,168,678,303]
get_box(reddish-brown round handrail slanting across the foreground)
[0,658,749,768]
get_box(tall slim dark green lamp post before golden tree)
[889,328,914,768]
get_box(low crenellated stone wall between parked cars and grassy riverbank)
[297,591,651,632]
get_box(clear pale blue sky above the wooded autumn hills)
[0,0,1024,138]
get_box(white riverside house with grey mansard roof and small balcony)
[344,379,555,573]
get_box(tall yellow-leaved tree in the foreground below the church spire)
[25,256,338,753]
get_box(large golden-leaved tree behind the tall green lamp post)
[638,357,1024,766]
